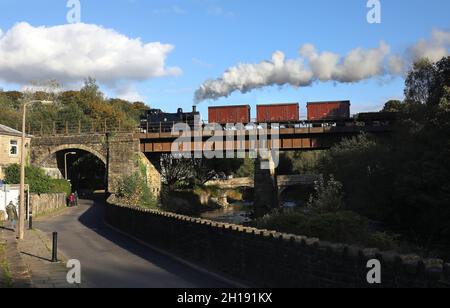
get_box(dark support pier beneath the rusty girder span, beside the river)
[254,156,280,217]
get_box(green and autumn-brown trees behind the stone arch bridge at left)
[0,78,148,131]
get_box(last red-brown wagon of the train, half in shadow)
[307,101,350,121]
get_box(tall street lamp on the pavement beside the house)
[18,100,53,240]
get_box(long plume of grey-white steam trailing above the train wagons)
[194,30,450,103]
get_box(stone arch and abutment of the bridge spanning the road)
[30,133,161,196]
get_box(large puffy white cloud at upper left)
[0,23,181,85]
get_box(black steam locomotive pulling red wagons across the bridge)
[141,106,200,133]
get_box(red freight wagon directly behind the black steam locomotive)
[208,105,250,125]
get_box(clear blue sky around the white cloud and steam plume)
[0,0,450,118]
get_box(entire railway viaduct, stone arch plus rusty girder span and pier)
[31,125,392,214]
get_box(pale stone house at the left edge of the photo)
[0,124,31,180]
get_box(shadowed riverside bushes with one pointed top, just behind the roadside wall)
[252,177,398,250]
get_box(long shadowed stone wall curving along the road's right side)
[106,196,450,288]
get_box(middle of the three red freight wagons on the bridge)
[257,103,300,123]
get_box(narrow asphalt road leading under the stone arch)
[35,200,231,288]
